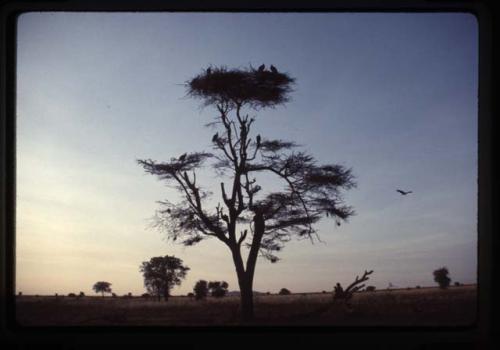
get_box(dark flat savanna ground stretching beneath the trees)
[16,285,476,326]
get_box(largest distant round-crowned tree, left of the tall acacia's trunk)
[140,255,189,301]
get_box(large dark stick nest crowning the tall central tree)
[186,67,295,108]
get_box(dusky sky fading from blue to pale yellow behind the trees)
[16,12,478,295]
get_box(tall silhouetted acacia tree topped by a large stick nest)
[138,67,355,321]
